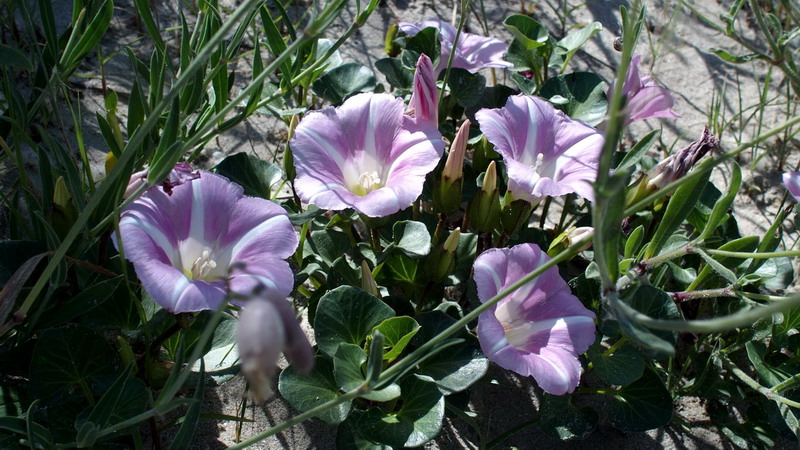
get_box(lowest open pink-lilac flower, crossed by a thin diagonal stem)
[474,244,595,395]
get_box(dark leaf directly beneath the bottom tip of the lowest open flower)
[538,394,598,441]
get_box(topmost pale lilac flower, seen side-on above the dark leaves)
[399,19,514,74]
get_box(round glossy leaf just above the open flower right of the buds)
[539,72,608,125]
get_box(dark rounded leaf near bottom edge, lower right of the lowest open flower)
[608,369,672,432]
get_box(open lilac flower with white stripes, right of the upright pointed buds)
[475,95,603,204]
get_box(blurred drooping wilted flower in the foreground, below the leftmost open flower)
[236,291,314,401]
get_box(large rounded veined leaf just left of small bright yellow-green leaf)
[314,286,394,356]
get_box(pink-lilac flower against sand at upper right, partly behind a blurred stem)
[608,55,680,125]
